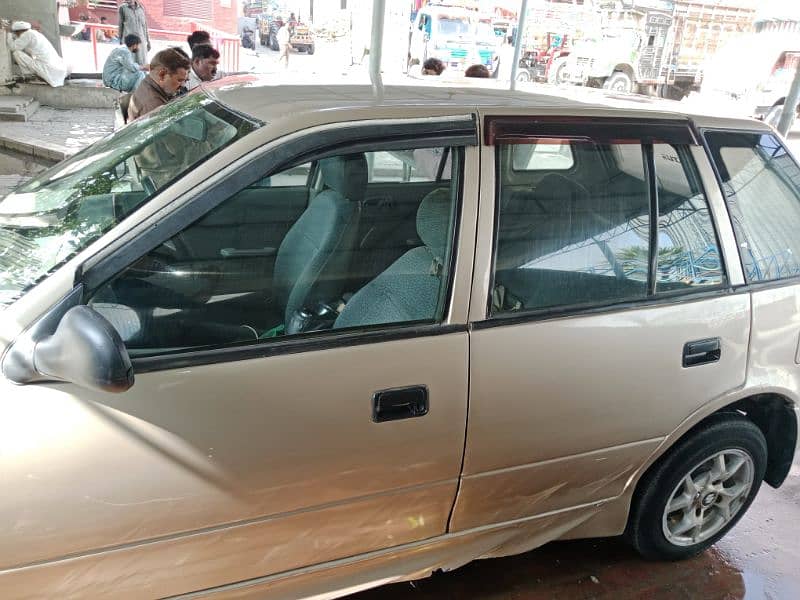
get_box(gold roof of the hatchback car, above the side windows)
[202,75,769,135]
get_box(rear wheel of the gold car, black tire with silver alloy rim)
[624,413,767,560]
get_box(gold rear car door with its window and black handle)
[451,118,750,543]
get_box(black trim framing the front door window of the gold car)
[75,115,478,373]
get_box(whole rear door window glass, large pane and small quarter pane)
[491,140,723,314]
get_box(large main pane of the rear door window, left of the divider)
[493,142,649,313]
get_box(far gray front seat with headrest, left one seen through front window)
[272,154,367,324]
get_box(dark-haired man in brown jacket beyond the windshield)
[128,48,190,122]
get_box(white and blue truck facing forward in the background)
[408,4,502,77]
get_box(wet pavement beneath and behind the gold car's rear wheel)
[348,457,800,600]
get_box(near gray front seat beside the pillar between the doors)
[333,189,451,329]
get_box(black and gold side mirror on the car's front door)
[33,305,133,393]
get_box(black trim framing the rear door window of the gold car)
[482,117,732,329]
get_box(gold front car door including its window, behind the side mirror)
[0,125,477,598]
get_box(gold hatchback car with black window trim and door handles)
[0,78,800,599]
